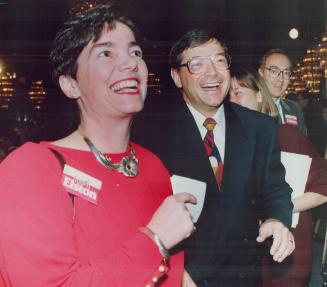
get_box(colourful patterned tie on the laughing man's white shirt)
[203,118,223,190]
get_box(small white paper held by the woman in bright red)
[170,175,207,222]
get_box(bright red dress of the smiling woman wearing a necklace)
[0,143,184,287]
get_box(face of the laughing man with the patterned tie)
[171,40,230,117]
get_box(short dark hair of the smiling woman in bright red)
[50,4,138,85]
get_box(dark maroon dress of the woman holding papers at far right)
[263,125,327,287]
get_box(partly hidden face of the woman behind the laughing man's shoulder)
[229,77,262,111]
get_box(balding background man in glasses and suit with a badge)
[259,49,308,136]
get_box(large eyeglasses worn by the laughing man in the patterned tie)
[178,53,232,74]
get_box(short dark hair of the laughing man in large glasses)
[169,29,227,69]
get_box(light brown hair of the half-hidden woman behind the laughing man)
[233,69,278,117]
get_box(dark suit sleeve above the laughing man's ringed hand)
[263,125,293,228]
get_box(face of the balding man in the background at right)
[259,54,291,100]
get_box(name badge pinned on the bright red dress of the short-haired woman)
[61,164,102,204]
